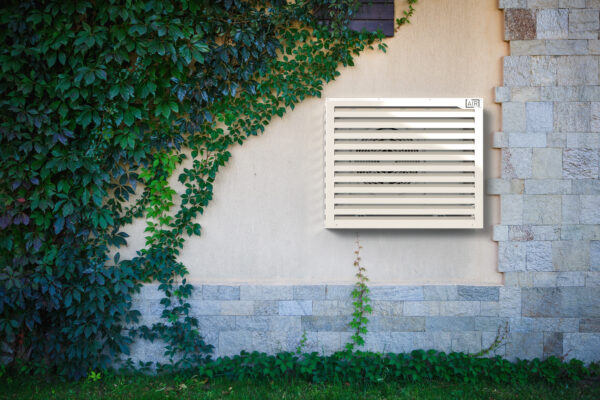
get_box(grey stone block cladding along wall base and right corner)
[132,0,600,362]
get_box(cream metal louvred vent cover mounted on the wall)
[325,98,483,229]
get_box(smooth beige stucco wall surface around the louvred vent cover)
[122,0,508,285]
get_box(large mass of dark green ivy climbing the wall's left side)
[0,0,413,378]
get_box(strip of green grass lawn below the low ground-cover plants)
[0,376,600,400]
